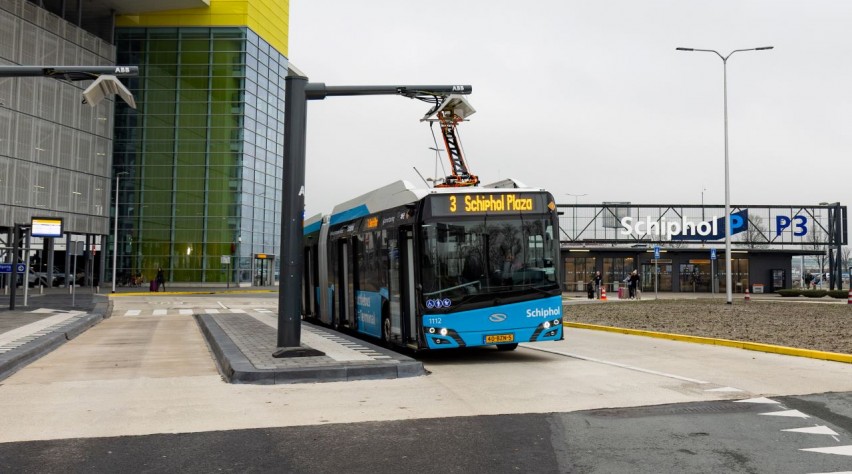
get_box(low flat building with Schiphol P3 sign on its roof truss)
[558,202,849,293]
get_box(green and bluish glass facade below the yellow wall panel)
[113,28,287,284]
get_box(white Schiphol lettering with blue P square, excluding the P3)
[621,210,748,240]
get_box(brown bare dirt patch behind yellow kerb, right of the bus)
[565,298,852,354]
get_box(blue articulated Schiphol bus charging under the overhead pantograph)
[302,181,563,350]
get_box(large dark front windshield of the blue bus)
[420,216,559,307]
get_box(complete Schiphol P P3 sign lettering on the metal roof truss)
[620,209,808,240]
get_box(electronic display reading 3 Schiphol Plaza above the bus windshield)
[432,193,546,216]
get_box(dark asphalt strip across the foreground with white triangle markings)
[0,394,852,473]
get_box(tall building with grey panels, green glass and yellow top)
[0,0,289,284]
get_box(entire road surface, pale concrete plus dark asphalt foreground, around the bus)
[0,295,852,472]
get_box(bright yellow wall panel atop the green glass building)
[116,0,290,57]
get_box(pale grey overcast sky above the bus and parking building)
[289,0,852,216]
